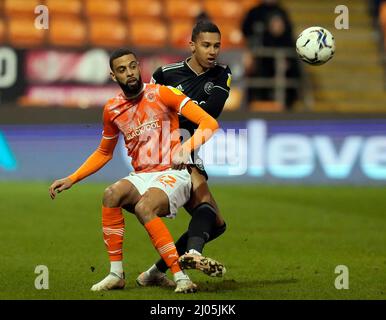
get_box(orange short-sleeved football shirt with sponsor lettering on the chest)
[103,84,190,172]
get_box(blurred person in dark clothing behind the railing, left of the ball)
[242,0,300,110]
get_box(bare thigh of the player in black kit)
[184,167,224,225]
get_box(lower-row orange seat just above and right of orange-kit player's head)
[129,18,168,48]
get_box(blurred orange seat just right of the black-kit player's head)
[213,19,245,49]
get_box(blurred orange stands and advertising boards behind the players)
[0,0,386,184]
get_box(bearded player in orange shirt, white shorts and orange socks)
[49,48,218,293]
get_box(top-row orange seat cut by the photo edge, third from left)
[84,0,122,18]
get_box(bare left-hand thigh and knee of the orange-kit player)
[103,179,141,209]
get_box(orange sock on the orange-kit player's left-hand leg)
[102,207,125,261]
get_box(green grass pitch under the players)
[0,182,386,300]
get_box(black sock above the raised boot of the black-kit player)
[187,202,216,253]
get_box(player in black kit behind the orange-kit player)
[137,20,232,286]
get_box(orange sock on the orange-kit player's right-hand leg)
[145,217,181,274]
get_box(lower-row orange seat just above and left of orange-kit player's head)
[89,18,127,47]
